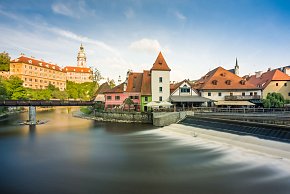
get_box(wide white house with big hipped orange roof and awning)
[193,67,261,106]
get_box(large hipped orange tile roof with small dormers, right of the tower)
[193,67,258,90]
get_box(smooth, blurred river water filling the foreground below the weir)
[0,108,290,194]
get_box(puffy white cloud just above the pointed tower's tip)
[129,38,161,53]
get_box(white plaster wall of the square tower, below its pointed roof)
[151,70,170,101]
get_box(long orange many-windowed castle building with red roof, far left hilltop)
[10,55,66,90]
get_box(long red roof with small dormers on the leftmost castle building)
[11,55,64,71]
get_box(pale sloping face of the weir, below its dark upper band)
[160,124,290,161]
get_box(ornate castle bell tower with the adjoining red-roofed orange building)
[64,44,93,83]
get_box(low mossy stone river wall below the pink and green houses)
[95,112,152,123]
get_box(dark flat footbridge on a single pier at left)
[0,100,95,125]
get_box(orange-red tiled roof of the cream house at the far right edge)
[248,69,290,89]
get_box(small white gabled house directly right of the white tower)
[170,80,211,109]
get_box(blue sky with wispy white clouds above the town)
[0,0,290,81]
